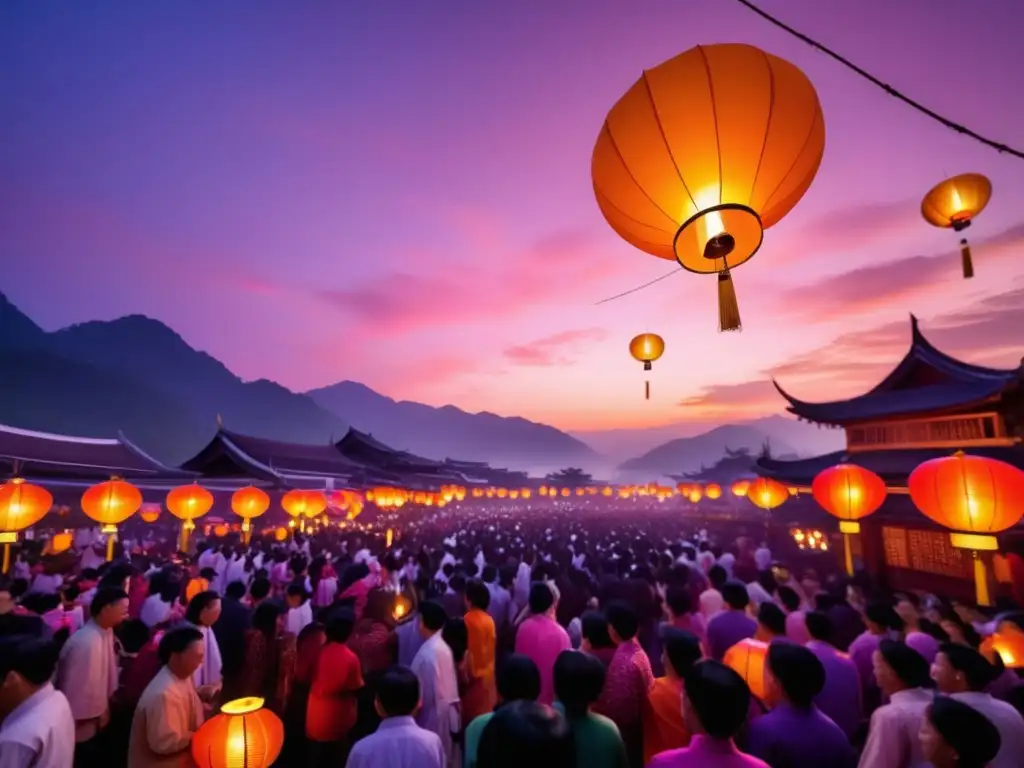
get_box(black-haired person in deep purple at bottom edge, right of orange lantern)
[745,643,857,768]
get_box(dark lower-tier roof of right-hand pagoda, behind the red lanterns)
[755,445,1024,487]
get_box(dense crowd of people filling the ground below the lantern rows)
[0,504,1024,768]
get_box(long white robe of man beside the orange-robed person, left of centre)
[412,632,462,766]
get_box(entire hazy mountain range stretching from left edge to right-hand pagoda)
[0,294,837,479]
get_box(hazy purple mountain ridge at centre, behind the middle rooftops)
[306,381,595,468]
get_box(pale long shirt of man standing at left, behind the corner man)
[55,621,118,741]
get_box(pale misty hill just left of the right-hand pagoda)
[620,416,843,475]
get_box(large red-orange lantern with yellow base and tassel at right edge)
[907,451,1024,605]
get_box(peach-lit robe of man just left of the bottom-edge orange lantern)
[128,667,203,768]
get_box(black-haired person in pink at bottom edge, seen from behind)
[647,659,769,768]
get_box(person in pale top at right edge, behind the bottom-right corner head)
[932,643,1024,768]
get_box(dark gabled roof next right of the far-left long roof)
[181,427,397,486]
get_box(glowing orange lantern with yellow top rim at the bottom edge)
[191,696,285,768]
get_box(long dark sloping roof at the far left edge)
[0,425,187,480]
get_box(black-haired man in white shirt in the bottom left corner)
[0,635,75,768]
